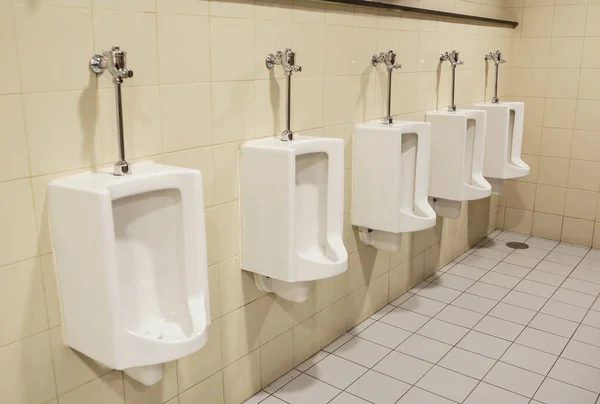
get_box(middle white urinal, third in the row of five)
[352,122,436,252]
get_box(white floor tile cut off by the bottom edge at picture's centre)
[274,374,340,404]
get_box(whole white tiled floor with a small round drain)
[246,232,600,404]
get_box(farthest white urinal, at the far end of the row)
[475,102,529,194]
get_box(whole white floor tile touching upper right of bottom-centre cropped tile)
[306,355,369,390]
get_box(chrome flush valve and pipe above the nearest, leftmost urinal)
[90,46,133,175]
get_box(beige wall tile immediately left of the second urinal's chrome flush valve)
[210,18,254,81]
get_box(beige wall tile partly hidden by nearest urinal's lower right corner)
[177,320,225,393]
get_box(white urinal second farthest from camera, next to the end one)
[426,109,491,217]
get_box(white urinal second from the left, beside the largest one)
[240,136,348,302]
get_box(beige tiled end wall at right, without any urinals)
[499,0,600,247]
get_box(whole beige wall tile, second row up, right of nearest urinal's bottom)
[221,302,260,366]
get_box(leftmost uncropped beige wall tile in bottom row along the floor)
[260,330,294,387]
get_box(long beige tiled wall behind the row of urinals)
[0,0,508,404]
